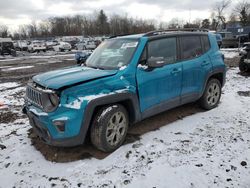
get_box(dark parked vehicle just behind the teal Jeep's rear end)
[218,31,239,48]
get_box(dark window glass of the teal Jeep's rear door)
[181,36,202,59]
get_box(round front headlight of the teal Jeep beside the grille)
[43,93,59,112]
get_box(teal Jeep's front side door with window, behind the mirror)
[136,37,182,112]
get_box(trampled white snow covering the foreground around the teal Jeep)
[0,69,250,188]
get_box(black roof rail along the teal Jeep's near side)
[143,28,209,37]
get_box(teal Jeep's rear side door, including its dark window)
[180,35,212,103]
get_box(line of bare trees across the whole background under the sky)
[0,0,250,39]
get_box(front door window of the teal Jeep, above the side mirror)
[148,37,177,63]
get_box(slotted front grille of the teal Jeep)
[26,86,43,108]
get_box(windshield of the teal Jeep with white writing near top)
[86,39,138,69]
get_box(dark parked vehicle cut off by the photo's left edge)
[0,38,16,56]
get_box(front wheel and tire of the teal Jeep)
[90,104,129,152]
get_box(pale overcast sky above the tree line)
[0,0,234,30]
